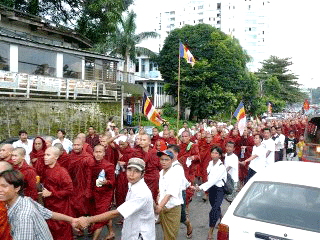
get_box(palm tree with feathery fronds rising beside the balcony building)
[97,11,159,82]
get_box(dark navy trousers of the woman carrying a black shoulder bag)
[208,185,224,227]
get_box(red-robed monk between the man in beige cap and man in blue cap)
[135,134,161,202]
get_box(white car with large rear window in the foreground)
[217,161,320,240]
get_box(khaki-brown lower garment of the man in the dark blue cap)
[160,205,181,240]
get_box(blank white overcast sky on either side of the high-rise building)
[134,0,320,87]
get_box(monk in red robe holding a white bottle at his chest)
[92,145,115,240]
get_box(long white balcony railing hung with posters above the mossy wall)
[0,70,121,102]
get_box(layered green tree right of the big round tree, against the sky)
[256,56,305,104]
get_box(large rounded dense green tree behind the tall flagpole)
[158,24,258,118]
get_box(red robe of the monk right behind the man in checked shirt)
[14,161,38,201]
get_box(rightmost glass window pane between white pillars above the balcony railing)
[63,53,82,79]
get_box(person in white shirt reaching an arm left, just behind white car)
[240,134,267,183]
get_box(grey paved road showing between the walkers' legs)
[80,191,230,240]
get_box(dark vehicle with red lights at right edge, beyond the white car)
[301,115,320,162]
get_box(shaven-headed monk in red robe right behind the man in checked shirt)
[12,147,38,201]
